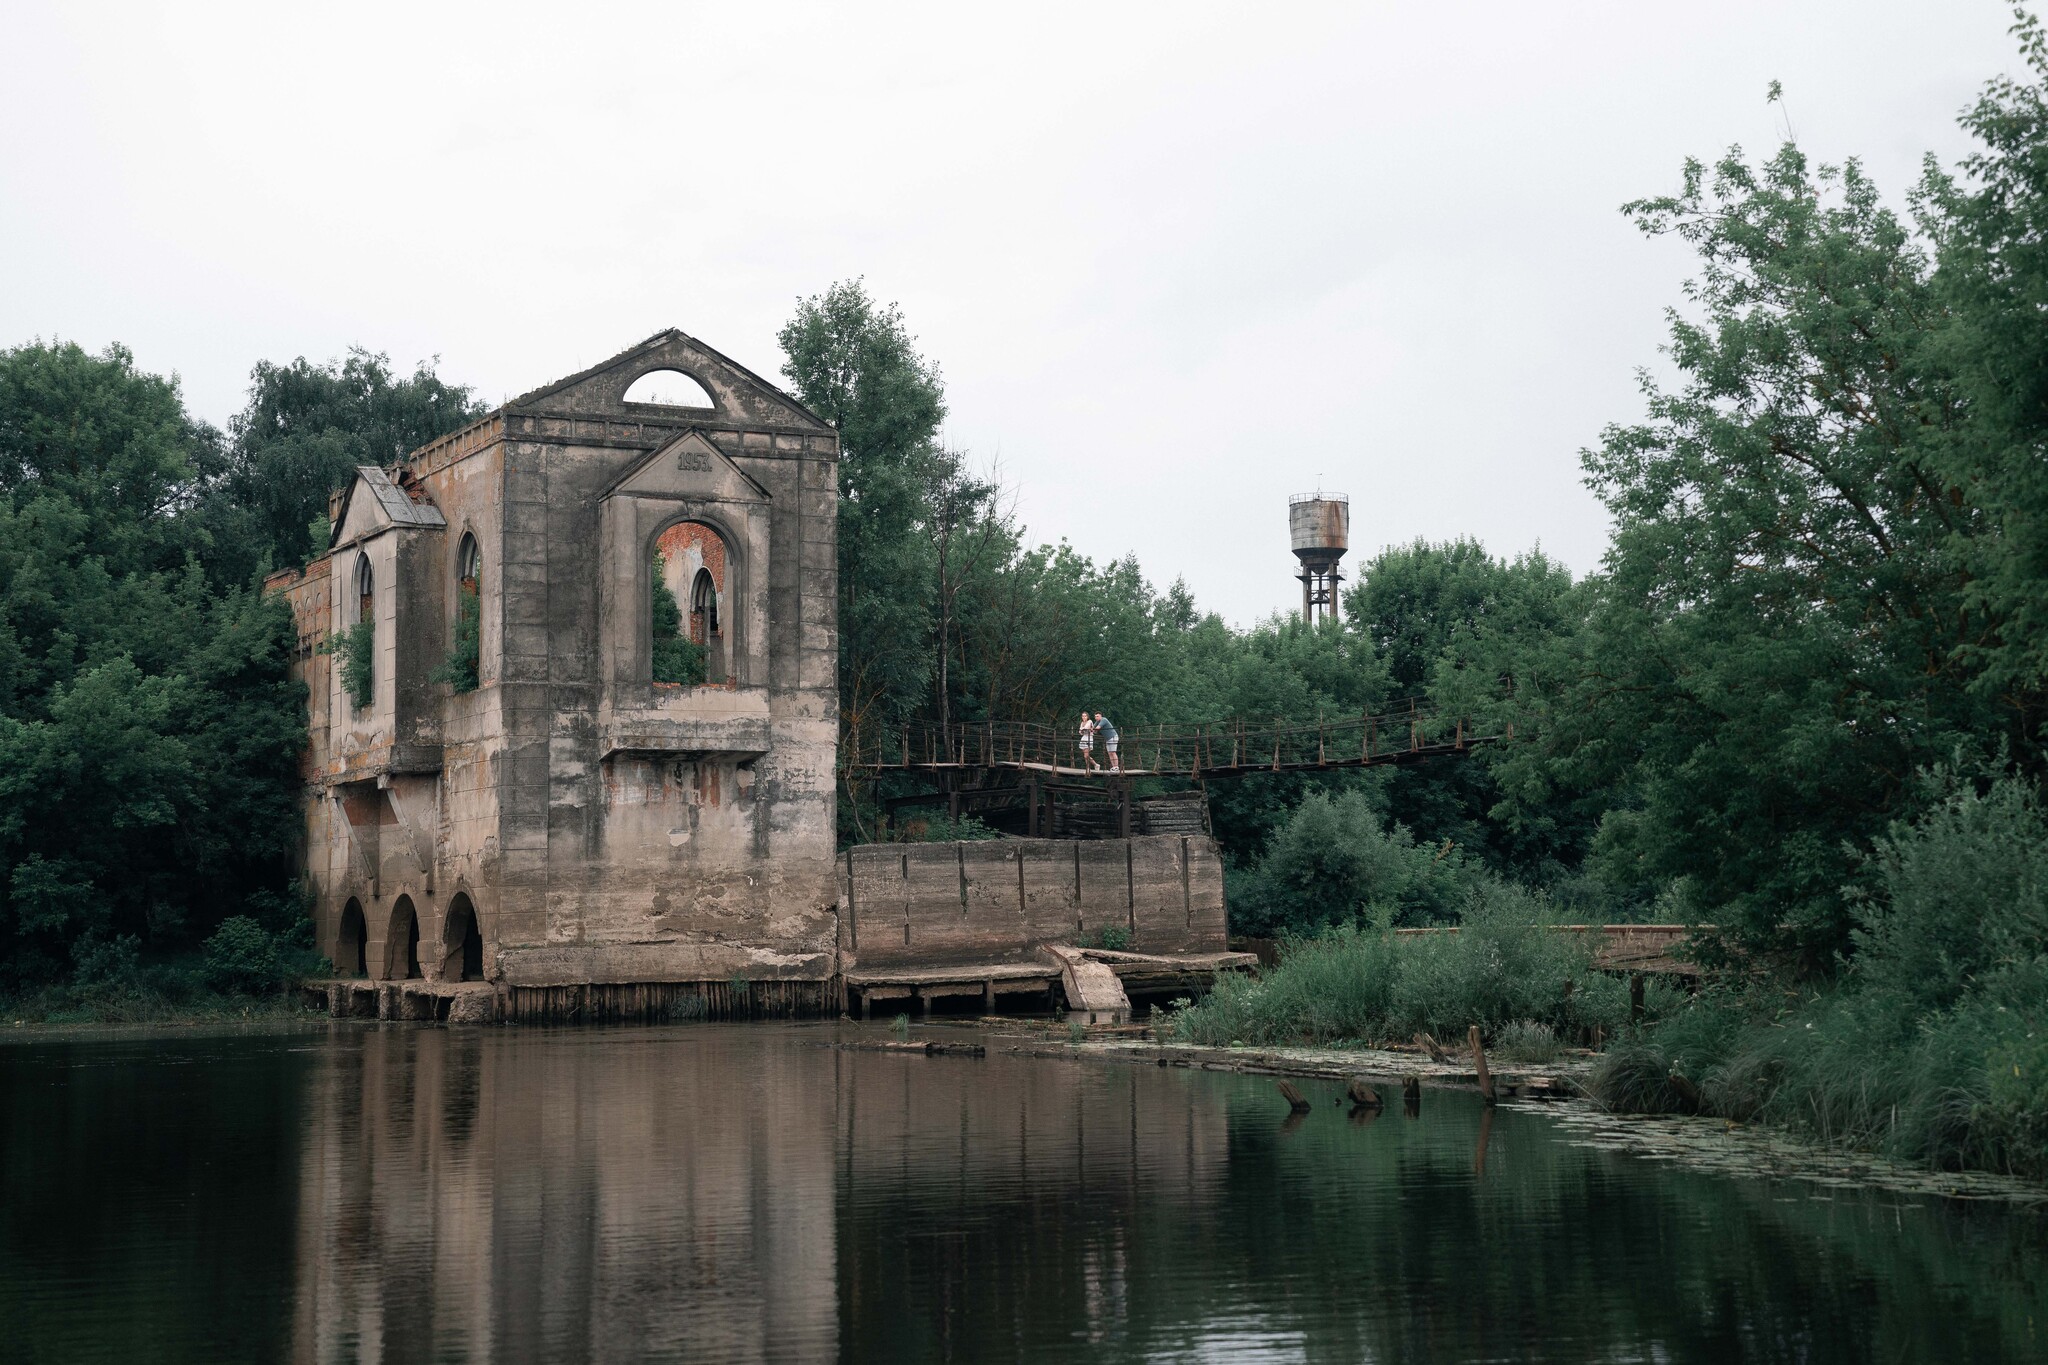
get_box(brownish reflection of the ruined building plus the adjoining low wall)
[293,1025,1227,1365]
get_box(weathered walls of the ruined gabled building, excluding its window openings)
[272,332,838,984]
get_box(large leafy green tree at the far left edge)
[0,346,305,986]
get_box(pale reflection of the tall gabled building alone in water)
[295,1031,838,1363]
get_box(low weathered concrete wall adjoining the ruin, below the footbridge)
[840,835,1227,970]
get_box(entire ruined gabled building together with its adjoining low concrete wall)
[272,332,1225,1017]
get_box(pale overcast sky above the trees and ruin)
[0,0,2019,624]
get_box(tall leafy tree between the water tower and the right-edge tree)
[1509,145,2001,966]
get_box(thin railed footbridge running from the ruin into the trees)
[842,704,1493,776]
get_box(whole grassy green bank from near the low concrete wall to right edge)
[1167,780,2048,1179]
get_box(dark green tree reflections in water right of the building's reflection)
[840,1068,2048,1361]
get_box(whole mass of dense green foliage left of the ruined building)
[0,342,473,1007]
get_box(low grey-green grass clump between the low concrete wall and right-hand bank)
[1167,884,1628,1046]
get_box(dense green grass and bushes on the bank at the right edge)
[1593,780,2048,1177]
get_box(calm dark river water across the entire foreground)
[0,1023,2048,1365]
